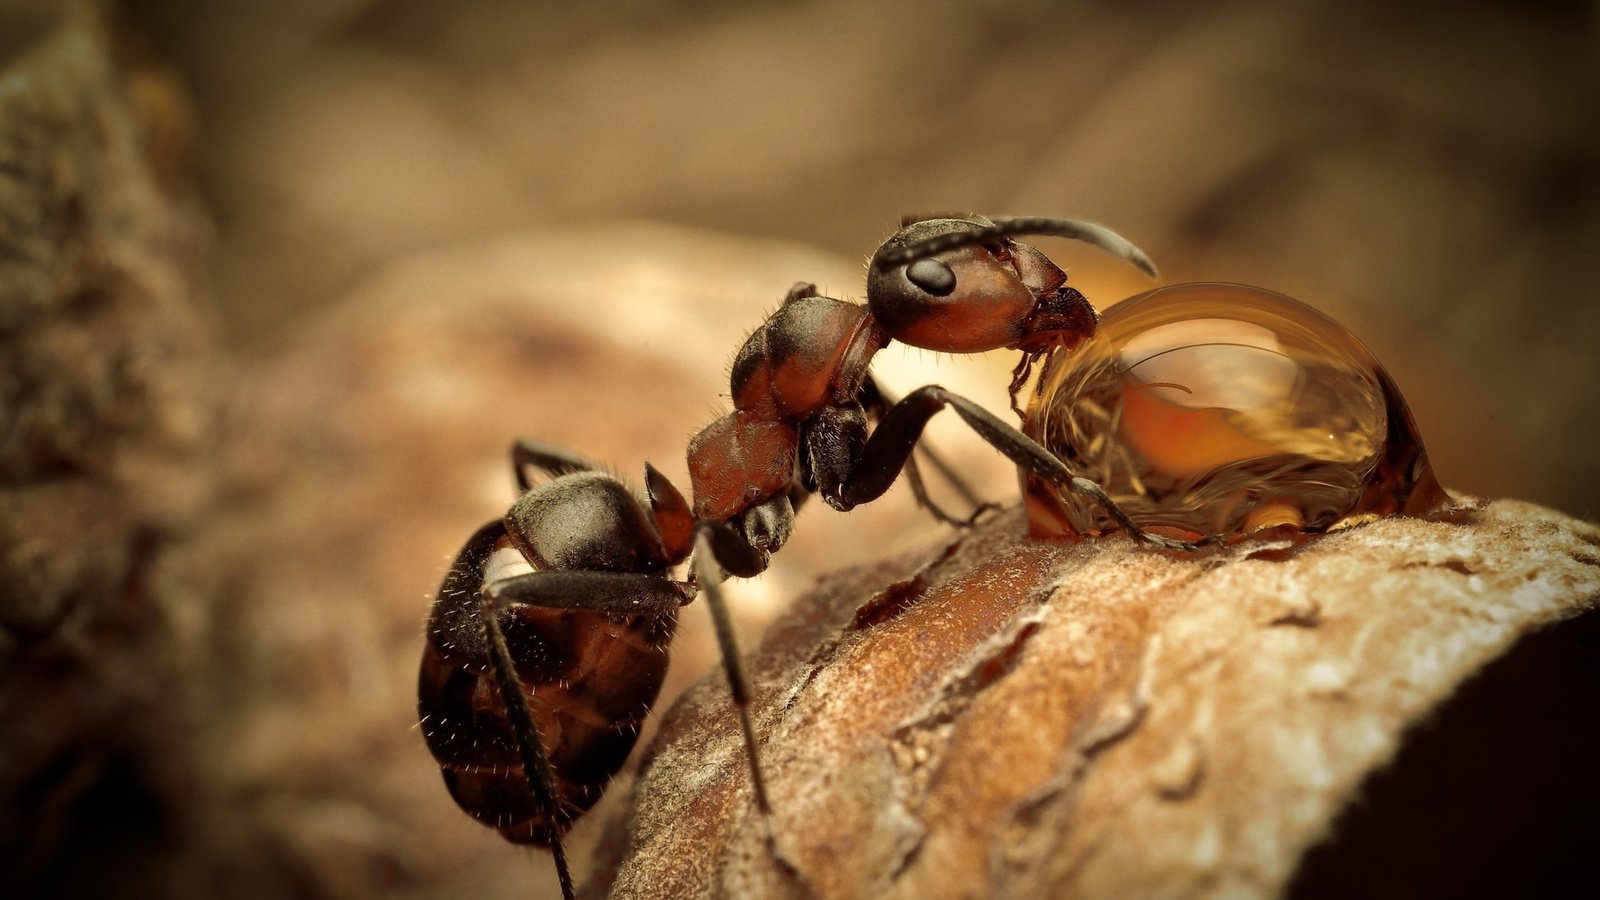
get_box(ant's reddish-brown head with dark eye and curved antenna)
[867,216,1155,352]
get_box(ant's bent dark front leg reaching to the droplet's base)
[838,384,1221,551]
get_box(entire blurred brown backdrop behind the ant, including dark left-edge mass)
[0,0,1600,897]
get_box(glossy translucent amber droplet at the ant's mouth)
[1024,283,1448,535]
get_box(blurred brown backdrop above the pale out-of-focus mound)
[128,0,1600,516]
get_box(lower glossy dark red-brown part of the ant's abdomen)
[418,496,677,846]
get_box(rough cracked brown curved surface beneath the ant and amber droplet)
[594,501,1600,897]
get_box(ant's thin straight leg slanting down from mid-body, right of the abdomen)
[691,522,803,882]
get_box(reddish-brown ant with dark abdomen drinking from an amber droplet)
[419,218,1216,898]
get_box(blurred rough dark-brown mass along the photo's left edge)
[0,13,216,892]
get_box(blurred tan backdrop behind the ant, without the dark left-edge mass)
[0,0,1600,895]
